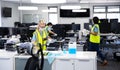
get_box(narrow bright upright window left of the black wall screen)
[48,6,58,24]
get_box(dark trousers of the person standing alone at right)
[88,42,105,61]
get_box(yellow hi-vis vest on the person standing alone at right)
[90,24,100,43]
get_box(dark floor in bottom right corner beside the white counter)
[97,60,120,70]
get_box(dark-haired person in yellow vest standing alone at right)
[88,17,107,65]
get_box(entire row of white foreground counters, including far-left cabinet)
[0,50,97,70]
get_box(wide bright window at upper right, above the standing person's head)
[93,6,120,22]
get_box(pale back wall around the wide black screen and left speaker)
[0,2,119,29]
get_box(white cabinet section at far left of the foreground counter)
[0,50,17,70]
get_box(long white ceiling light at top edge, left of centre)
[31,0,66,4]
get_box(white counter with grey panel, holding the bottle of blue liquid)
[15,51,97,70]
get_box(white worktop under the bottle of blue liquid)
[15,51,96,59]
